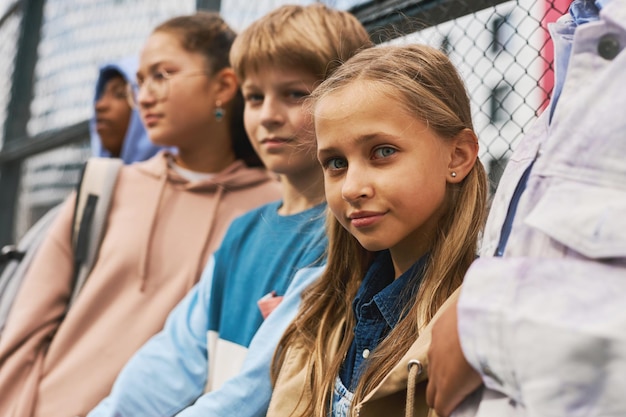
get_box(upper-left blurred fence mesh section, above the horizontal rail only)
[28,0,195,134]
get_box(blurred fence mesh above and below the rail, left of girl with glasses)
[15,0,195,236]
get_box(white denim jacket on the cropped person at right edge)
[458,0,626,417]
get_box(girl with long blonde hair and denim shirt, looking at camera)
[268,45,487,417]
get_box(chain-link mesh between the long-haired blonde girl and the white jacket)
[390,0,567,191]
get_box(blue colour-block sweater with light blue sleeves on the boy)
[89,202,327,417]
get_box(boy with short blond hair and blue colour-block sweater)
[89,4,371,417]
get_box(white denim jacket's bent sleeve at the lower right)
[458,257,626,416]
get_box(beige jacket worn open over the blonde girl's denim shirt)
[267,289,460,417]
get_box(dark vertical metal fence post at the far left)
[0,0,45,246]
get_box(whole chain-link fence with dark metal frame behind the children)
[0,0,570,245]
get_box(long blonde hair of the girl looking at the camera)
[272,45,487,417]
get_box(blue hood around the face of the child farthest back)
[89,56,167,164]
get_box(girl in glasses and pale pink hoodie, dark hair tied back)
[0,12,280,417]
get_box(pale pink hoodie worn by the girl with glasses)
[0,153,280,417]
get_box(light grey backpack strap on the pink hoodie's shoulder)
[68,157,123,308]
